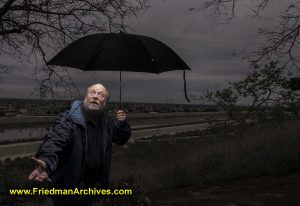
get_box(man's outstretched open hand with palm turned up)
[28,157,51,182]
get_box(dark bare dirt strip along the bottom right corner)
[149,173,300,206]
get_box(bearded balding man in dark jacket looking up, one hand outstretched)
[28,84,131,206]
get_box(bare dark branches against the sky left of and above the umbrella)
[0,0,148,98]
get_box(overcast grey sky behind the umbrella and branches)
[0,0,285,103]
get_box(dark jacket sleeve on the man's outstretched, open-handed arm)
[35,112,72,175]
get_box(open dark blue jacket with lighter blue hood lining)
[35,100,131,189]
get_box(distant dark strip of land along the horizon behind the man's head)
[0,98,218,116]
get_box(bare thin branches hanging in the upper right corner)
[190,0,300,75]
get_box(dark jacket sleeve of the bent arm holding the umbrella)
[112,117,131,145]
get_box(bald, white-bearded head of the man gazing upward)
[84,84,108,112]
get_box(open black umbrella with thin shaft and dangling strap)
[47,33,191,103]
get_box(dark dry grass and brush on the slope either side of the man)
[0,120,300,205]
